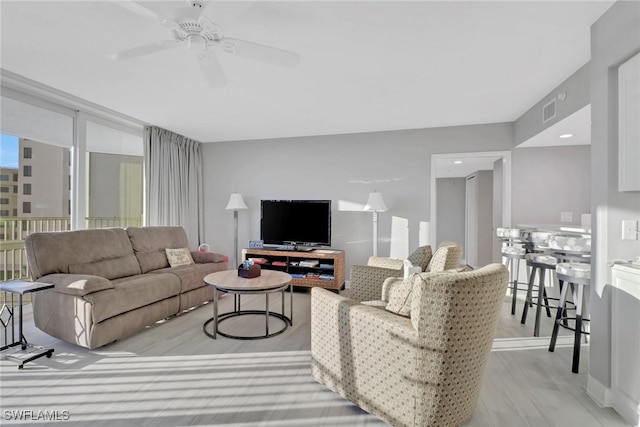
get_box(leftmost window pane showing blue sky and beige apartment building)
[0,95,74,280]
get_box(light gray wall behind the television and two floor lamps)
[202,123,513,271]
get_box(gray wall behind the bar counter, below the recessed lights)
[511,145,591,225]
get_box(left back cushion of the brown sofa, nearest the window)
[25,228,140,280]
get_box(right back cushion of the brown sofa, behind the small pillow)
[126,226,189,273]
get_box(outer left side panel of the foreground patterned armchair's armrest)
[311,288,422,425]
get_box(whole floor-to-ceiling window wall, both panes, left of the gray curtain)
[0,89,144,281]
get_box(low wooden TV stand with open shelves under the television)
[242,249,344,290]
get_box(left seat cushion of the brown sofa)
[84,274,180,323]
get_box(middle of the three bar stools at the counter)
[520,231,558,337]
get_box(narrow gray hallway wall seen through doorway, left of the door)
[436,178,466,251]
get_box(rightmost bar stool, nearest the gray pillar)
[549,234,591,374]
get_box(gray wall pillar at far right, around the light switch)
[587,1,640,403]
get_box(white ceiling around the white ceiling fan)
[0,0,613,142]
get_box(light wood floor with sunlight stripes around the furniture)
[0,290,627,427]
